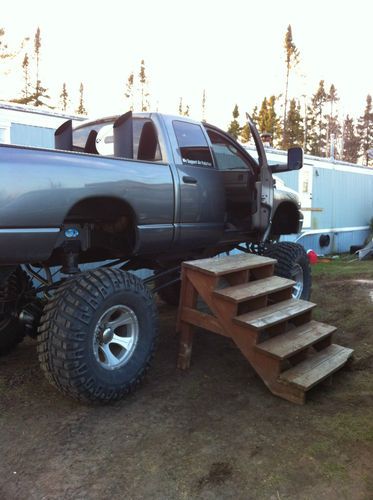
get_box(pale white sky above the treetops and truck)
[0,0,373,128]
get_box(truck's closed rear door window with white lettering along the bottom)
[173,120,214,167]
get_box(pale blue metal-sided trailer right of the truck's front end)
[256,148,373,255]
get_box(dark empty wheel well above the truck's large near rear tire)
[64,196,136,254]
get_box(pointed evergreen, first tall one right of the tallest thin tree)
[306,80,328,156]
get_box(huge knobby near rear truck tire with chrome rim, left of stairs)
[38,269,158,402]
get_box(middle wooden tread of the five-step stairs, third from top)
[234,299,316,330]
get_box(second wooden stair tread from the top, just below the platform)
[214,276,295,302]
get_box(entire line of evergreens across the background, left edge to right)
[0,25,373,165]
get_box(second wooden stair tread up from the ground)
[256,320,336,360]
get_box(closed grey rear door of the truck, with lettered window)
[170,119,225,248]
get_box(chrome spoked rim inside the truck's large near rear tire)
[93,304,139,370]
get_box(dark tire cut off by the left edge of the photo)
[0,267,32,354]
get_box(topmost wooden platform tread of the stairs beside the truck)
[183,254,277,276]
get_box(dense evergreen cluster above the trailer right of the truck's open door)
[228,25,373,166]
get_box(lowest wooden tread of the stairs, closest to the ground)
[279,344,353,391]
